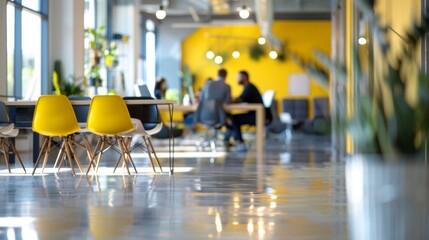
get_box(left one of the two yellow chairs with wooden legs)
[33,95,88,175]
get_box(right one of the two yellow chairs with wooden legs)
[86,95,137,174]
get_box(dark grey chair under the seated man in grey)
[195,99,226,152]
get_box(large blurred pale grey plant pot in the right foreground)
[346,155,429,240]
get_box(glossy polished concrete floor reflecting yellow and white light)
[0,134,348,239]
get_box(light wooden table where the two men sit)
[160,103,265,156]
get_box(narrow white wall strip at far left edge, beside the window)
[0,0,7,99]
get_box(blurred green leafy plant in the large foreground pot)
[291,0,429,158]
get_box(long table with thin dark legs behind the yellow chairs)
[5,99,175,174]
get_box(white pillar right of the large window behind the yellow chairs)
[49,0,85,84]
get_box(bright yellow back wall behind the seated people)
[182,21,331,116]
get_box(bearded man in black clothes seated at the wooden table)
[224,71,263,151]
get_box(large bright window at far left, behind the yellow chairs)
[7,0,50,99]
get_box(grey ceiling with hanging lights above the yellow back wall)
[140,0,331,24]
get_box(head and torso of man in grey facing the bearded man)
[200,68,231,104]
